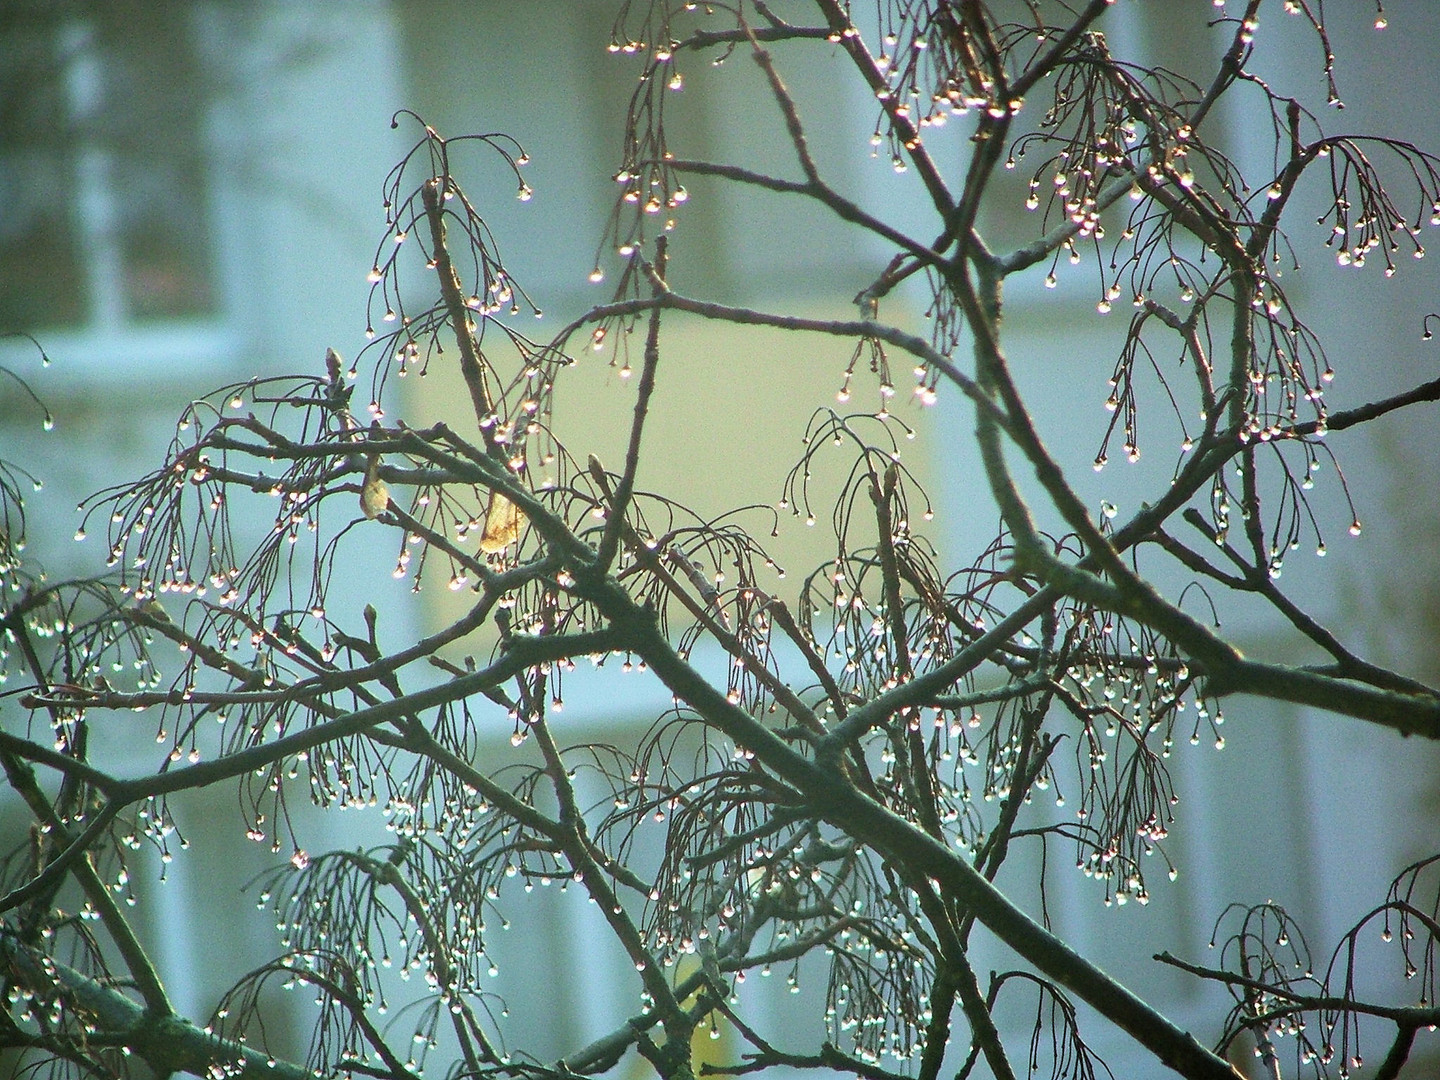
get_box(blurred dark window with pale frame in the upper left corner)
[0,0,219,365]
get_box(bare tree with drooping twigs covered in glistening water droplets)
[8,0,1440,1080]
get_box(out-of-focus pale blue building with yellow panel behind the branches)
[0,0,1440,1076]
